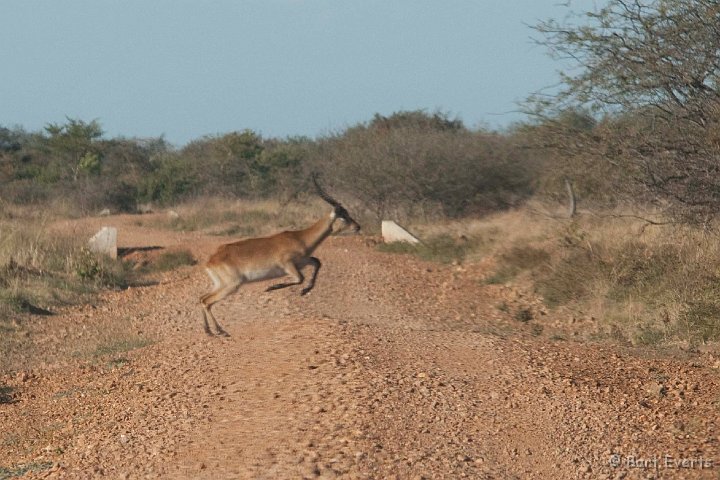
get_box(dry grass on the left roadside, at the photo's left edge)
[0,212,146,372]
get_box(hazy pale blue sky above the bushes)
[0,0,593,145]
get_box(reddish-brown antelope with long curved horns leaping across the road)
[200,175,360,337]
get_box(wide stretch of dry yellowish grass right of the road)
[396,209,720,346]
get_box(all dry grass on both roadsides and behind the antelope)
[5,198,720,352]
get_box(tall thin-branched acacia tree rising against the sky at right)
[527,0,720,221]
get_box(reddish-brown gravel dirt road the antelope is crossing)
[0,217,720,479]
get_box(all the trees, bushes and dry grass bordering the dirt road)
[0,0,720,345]
